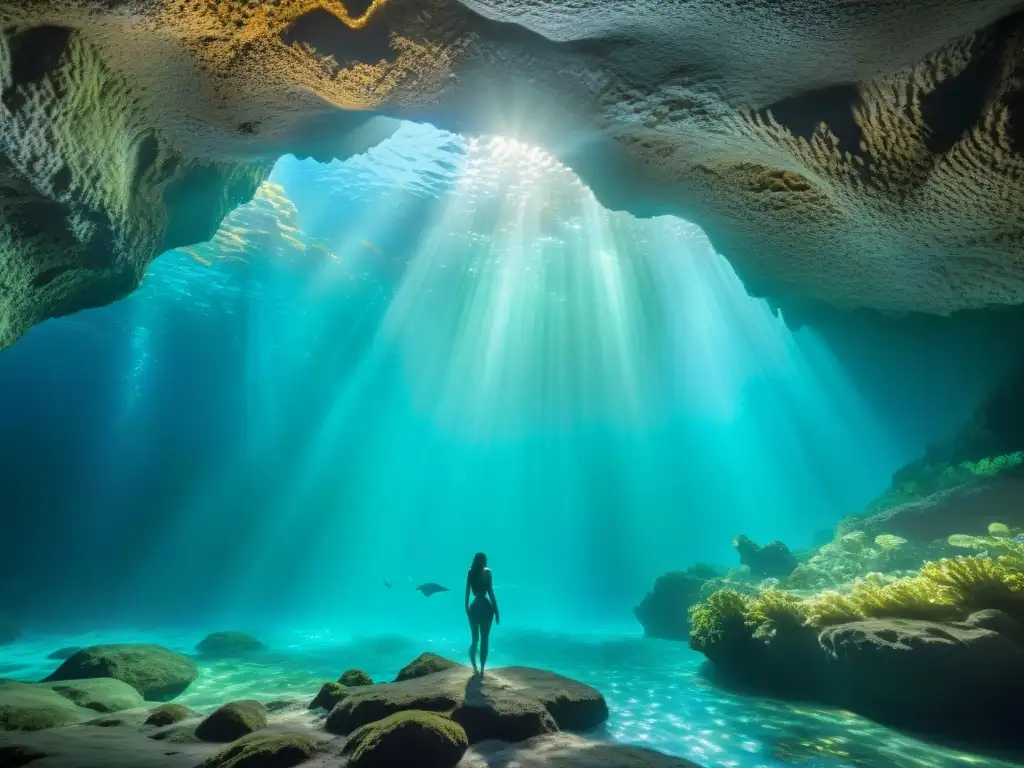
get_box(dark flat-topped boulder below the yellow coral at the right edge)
[819,616,1024,739]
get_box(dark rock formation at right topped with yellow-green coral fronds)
[690,539,1024,748]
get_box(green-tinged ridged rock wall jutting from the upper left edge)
[0,20,270,346]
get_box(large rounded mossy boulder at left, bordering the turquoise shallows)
[45,644,199,701]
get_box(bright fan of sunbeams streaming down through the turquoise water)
[28,127,904,629]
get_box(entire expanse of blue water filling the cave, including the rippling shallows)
[0,126,1009,768]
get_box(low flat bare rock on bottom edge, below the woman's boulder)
[458,733,699,768]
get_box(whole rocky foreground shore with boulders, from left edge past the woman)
[0,656,693,768]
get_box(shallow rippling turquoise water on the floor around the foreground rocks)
[0,629,1014,768]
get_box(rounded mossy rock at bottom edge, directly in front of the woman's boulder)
[344,710,469,768]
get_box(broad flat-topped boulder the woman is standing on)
[326,665,608,743]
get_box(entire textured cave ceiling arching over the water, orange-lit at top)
[0,0,1024,347]
